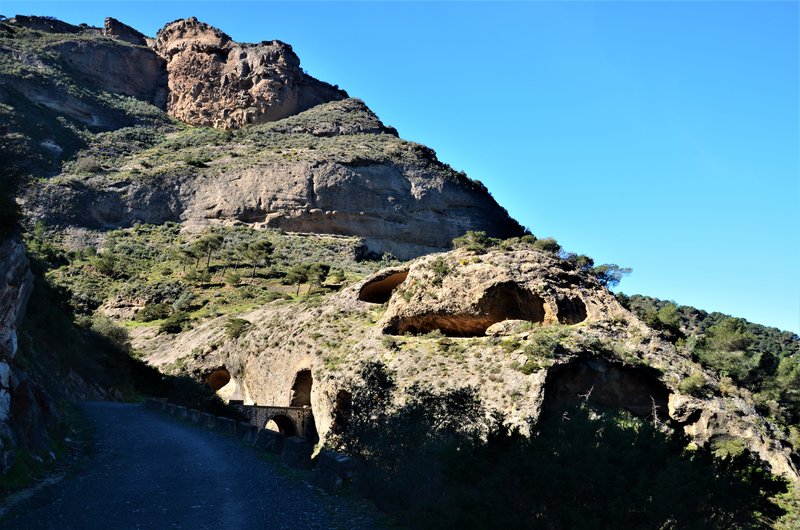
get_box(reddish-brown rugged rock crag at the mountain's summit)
[155,18,347,129]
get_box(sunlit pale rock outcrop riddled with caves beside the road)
[136,246,798,479]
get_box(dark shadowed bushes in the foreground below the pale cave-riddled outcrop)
[334,363,786,529]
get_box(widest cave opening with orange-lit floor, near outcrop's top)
[384,282,545,337]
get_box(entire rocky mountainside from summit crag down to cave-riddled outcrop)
[0,12,800,526]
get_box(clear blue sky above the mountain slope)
[6,0,800,332]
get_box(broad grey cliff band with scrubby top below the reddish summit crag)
[27,99,523,259]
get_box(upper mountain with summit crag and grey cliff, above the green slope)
[0,17,523,258]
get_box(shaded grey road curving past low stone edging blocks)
[0,402,384,530]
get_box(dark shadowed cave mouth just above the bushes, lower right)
[542,359,669,421]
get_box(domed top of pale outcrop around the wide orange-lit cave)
[382,251,608,337]
